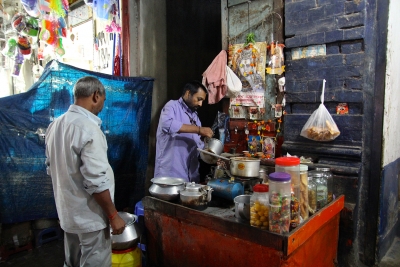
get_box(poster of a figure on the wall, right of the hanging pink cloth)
[228,42,267,108]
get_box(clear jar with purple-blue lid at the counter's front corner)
[269,172,291,234]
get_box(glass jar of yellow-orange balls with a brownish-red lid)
[250,184,269,230]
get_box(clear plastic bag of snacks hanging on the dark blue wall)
[300,79,340,141]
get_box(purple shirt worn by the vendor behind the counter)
[154,97,204,183]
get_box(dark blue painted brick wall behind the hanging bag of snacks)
[282,0,368,266]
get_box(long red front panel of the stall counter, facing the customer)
[145,210,283,267]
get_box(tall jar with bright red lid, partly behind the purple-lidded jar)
[275,157,300,229]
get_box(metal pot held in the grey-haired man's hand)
[110,211,141,250]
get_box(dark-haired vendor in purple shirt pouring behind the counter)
[154,81,213,183]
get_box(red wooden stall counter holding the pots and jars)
[143,196,344,267]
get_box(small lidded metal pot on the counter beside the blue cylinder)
[180,182,213,210]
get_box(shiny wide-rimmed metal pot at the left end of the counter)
[149,177,186,201]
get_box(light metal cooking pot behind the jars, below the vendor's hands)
[230,157,261,177]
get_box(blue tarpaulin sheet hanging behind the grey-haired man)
[0,61,154,223]
